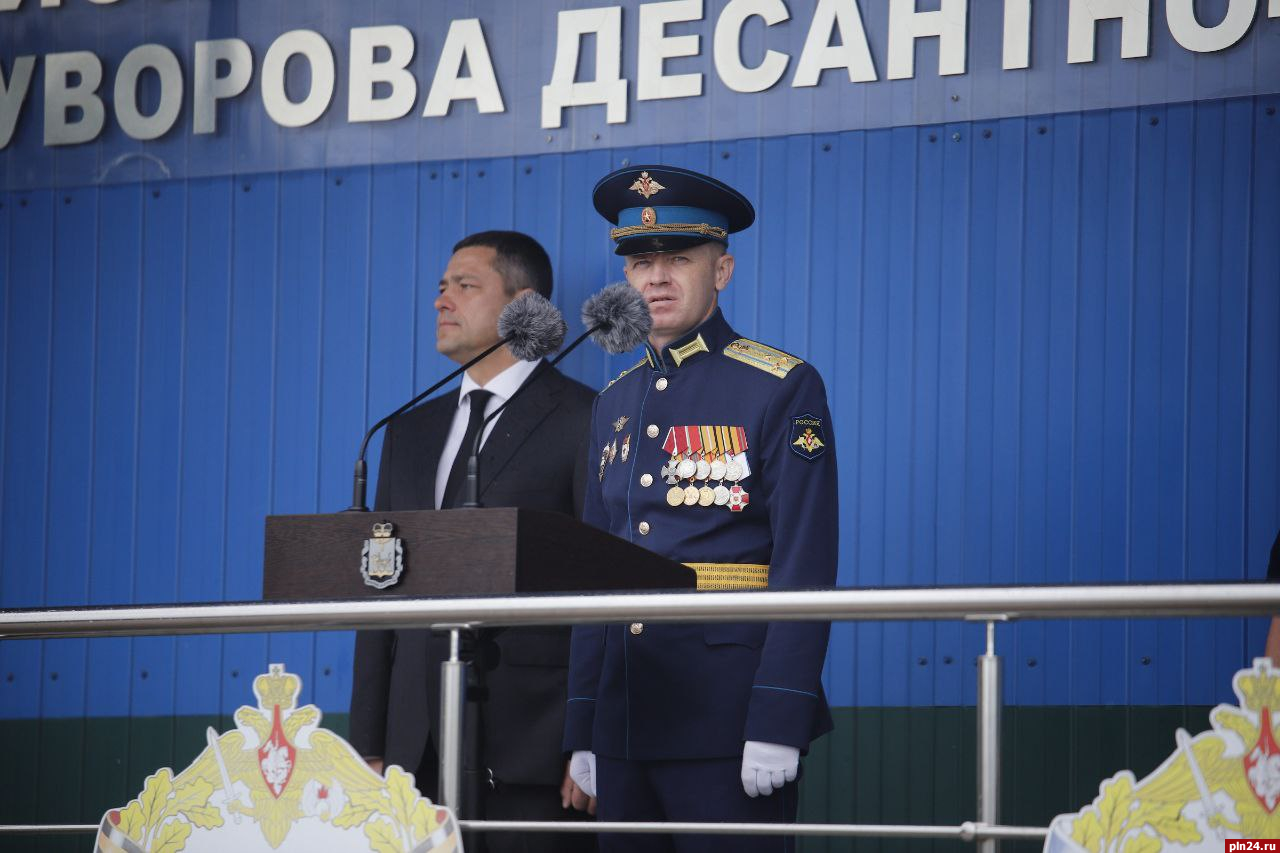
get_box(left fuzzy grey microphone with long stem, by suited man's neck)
[347,292,568,512]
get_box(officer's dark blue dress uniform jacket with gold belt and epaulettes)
[564,309,838,761]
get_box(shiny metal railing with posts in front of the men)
[0,584,1280,853]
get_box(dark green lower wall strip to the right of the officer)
[800,706,1212,853]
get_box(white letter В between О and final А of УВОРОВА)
[347,24,417,122]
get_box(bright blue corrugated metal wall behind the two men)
[0,97,1280,717]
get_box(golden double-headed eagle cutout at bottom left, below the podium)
[95,663,462,853]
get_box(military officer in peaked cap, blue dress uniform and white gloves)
[564,165,838,850]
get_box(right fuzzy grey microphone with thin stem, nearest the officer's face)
[462,282,653,508]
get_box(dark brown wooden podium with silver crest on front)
[262,507,698,601]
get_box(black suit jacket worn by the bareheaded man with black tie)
[351,361,595,783]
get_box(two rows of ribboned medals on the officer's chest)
[659,425,750,512]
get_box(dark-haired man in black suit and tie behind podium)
[351,231,595,853]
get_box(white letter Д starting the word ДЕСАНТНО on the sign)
[543,6,627,128]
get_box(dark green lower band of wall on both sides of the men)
[0,706,1211,853]
